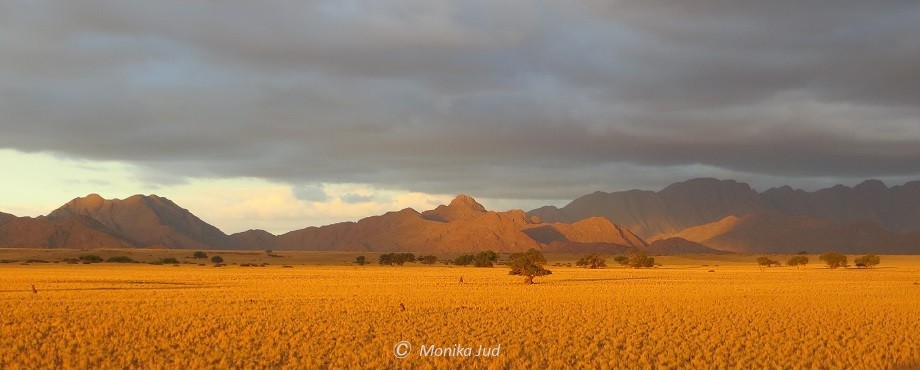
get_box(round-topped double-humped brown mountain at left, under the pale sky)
[46,194,231,249]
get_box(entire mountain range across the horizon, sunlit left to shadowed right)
[0,179,920,254]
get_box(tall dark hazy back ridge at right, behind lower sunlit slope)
[529,178,920,238]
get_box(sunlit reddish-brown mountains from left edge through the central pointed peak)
[0,194,676,253]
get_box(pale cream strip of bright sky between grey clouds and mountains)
[0,149,545,234]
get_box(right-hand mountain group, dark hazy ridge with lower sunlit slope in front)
[528,178,920,254]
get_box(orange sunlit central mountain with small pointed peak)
[260,195,712,253]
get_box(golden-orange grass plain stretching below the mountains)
[0,250,920,369]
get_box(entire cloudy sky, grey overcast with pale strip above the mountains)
[0,0,920,232]
